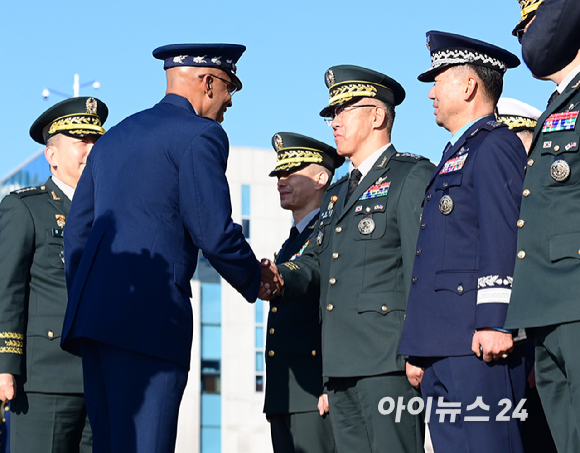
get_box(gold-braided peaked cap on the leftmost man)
[30,97,109,145]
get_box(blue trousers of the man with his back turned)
[81,340,187,453]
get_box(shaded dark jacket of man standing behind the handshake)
[264,216,323,415]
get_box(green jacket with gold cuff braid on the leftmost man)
[0,179,83,393]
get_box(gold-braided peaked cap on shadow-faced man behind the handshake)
[270,132,344,176]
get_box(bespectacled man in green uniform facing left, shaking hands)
[260,65,433,453]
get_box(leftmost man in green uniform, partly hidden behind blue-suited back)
[0,97,108,453]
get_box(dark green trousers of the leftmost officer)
[10,389,92,453]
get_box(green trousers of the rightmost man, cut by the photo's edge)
[533,322,580,453]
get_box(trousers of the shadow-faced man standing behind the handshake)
[268,412,336,453]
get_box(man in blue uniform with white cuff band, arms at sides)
[399,31,526,453]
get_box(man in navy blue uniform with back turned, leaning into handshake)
[62,44,261,453]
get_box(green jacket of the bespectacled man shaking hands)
[274,145,434,378]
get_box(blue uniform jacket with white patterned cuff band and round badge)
[399,115,526,357]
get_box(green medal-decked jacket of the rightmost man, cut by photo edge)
[505,74,580,329]
